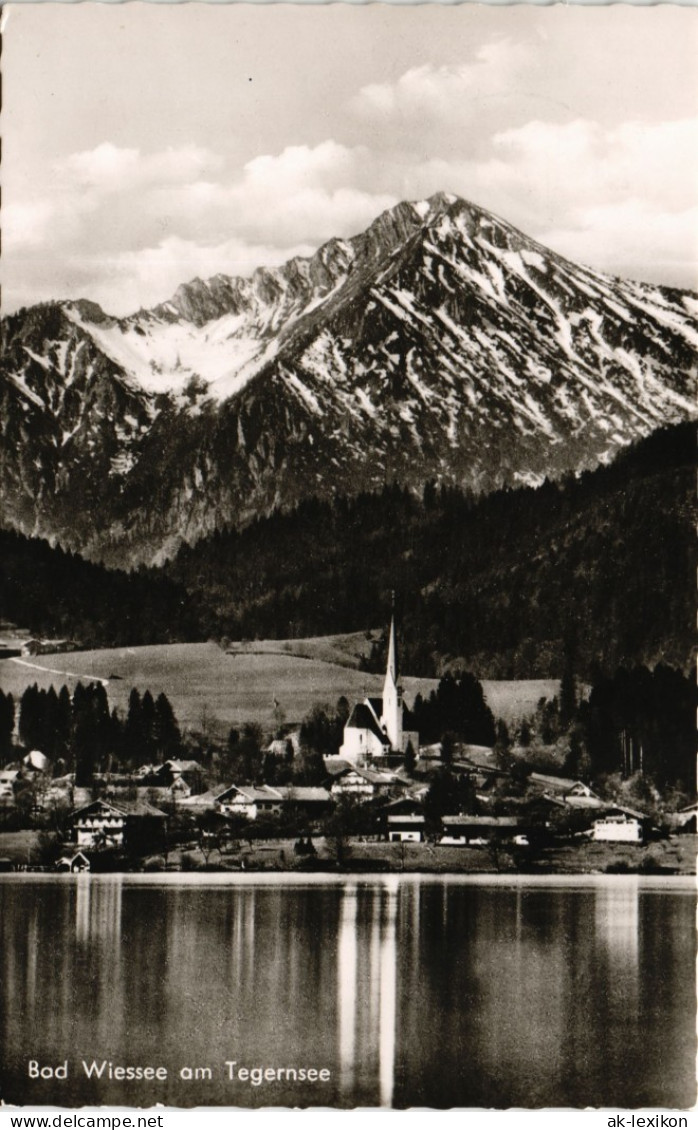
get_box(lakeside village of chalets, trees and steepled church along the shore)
[0,616,697,873]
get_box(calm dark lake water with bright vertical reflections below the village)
[0,875,696,1109]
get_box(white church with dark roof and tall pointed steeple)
[339,614,419,767]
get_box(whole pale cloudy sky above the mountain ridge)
[2,2,698,315]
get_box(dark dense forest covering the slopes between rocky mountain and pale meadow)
[0,424,696,680]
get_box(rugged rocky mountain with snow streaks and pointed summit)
[0,194,698,565]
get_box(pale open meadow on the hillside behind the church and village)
[0,633,558,736]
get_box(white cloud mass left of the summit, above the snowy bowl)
[3,140,398,315]
